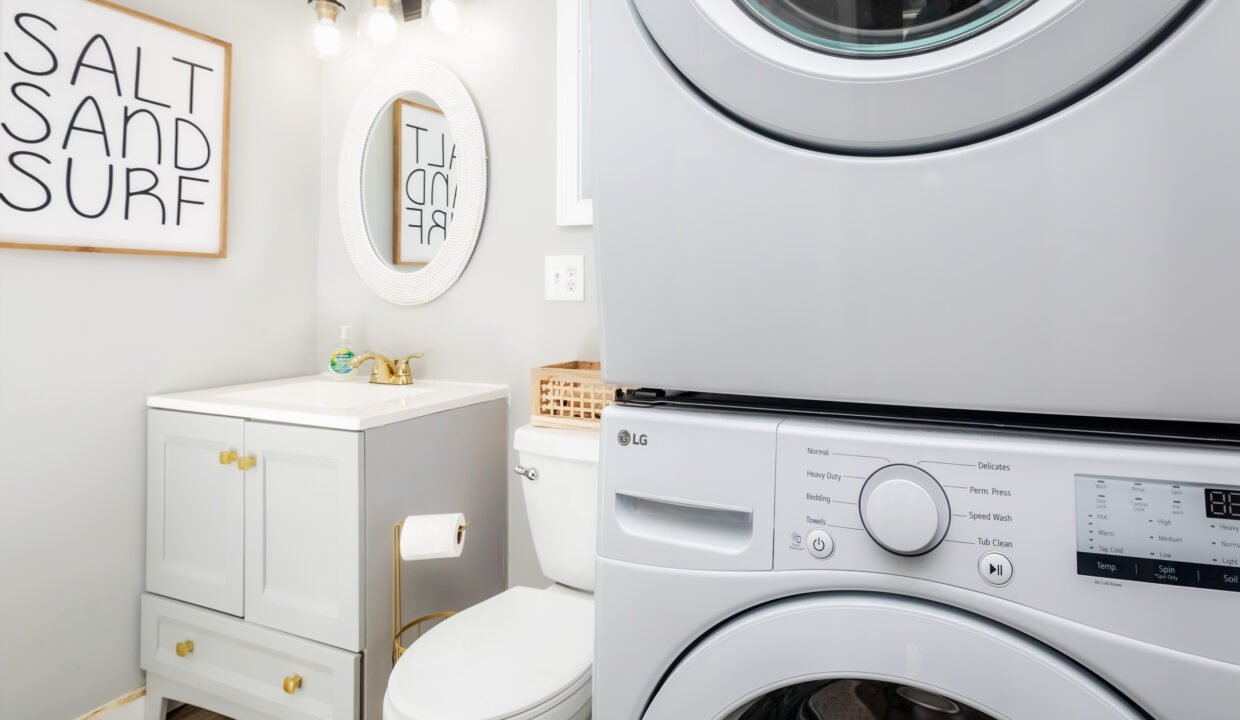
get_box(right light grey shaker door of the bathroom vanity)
[246,423,362,652]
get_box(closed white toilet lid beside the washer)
[387,586,594,720]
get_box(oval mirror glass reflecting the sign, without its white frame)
[362,92,458,273]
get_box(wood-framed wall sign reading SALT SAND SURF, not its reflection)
[0,0,232,258]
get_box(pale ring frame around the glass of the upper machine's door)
[632,0,1192,155]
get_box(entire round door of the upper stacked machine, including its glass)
[631,0,1198,155]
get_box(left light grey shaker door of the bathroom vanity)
[146,410,246,615]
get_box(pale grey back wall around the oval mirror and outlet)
[317,0,598,584]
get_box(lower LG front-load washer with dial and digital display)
[594,406,1240,720]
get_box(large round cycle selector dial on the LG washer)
[859,465,951,555]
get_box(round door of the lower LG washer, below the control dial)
[645,594,1146,720]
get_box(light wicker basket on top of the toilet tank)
[529,361,629,430]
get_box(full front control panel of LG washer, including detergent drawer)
[599,405,1240,663]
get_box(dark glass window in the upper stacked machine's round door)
[740,0,1033,57]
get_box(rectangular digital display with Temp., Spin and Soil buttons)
[1076,475,1240,592]
